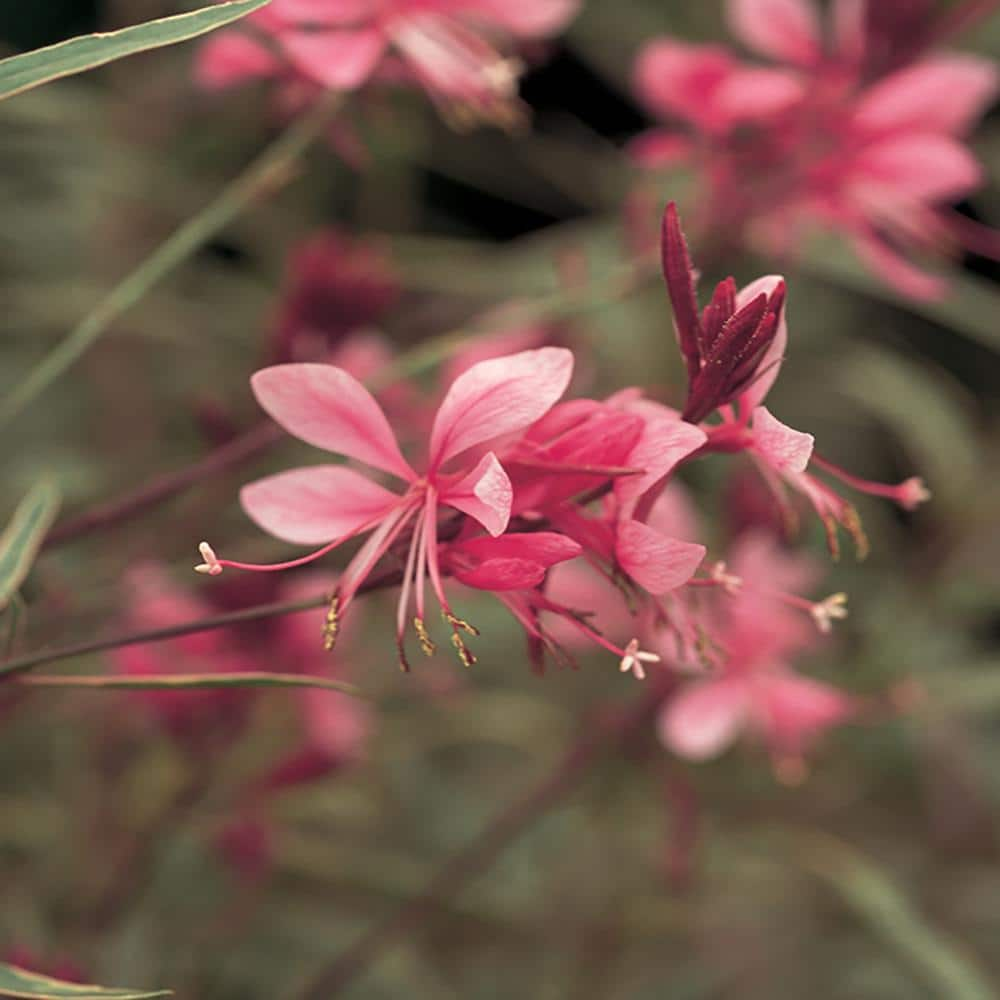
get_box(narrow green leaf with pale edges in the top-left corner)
[0,0,270,100]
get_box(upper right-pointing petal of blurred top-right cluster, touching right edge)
[854,55,1000,135]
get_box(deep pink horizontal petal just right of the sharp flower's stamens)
[448,531,583,590]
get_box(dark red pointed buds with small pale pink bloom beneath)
[662,203,930,557]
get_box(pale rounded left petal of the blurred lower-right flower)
[657,681,749,760]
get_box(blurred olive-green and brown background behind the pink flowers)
[0,0,1000,1000]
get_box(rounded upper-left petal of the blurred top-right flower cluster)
[634,39,733,128]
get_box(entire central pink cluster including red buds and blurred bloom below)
[197,205,927,776]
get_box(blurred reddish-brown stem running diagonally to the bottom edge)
[297,685,669,1000]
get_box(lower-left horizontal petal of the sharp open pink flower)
[240,465,400,545]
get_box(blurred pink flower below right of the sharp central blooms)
[659,535,856,779]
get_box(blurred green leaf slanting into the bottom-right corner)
[795,832,998,1000]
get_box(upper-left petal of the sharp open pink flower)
[250,364,416,480]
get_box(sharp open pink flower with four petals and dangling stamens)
[197,347,576,668]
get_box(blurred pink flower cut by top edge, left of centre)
[197,0,578,121]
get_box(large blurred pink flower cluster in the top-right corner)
[632,0,1000,298]
